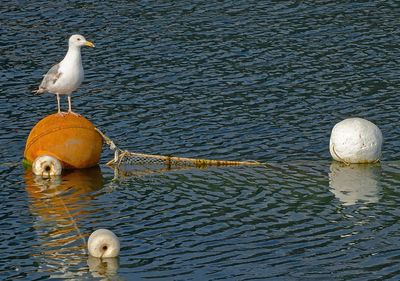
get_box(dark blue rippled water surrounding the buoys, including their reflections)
[0,1,400,280]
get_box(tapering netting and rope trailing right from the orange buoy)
[96,128,264,171]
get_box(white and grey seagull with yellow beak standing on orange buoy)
[36,35,94,115]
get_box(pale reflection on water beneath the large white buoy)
[329,161,381,206]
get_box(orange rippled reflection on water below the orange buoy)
[22,166,104,279]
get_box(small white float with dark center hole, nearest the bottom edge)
[88,229,120,258]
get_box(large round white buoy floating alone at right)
[329,118,383,163]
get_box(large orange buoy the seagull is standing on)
[24,113,103,169]
